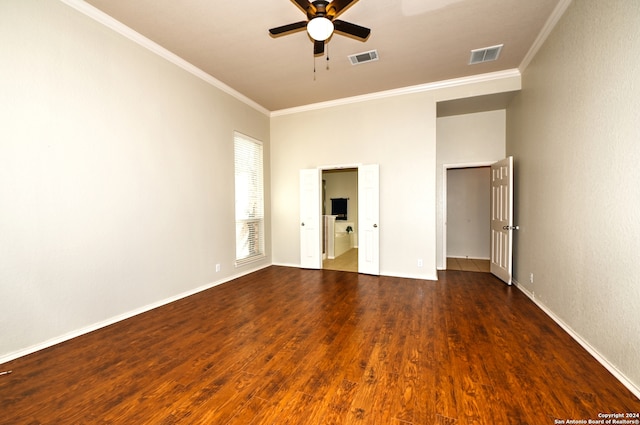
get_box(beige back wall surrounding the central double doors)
[271,93,436,279]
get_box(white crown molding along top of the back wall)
[271,68,521,117]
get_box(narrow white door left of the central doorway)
[300,169,322,269]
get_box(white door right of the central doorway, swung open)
[358,164,380,275]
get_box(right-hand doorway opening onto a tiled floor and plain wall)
[442,163,491,273]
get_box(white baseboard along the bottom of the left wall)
[0,264,271,364]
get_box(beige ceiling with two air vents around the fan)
[86,0,560,111]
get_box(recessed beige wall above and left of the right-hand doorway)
[436,109,506,269]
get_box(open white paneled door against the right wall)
[491,156,517,285]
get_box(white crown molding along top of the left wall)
[59,0,269,116]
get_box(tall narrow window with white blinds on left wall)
[233,132,264,265]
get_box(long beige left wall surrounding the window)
[0,0,271,361]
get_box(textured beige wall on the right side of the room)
[507,0,640,393]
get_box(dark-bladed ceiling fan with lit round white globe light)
[269,0,371,55]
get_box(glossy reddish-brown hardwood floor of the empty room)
[0,266,640,425]
